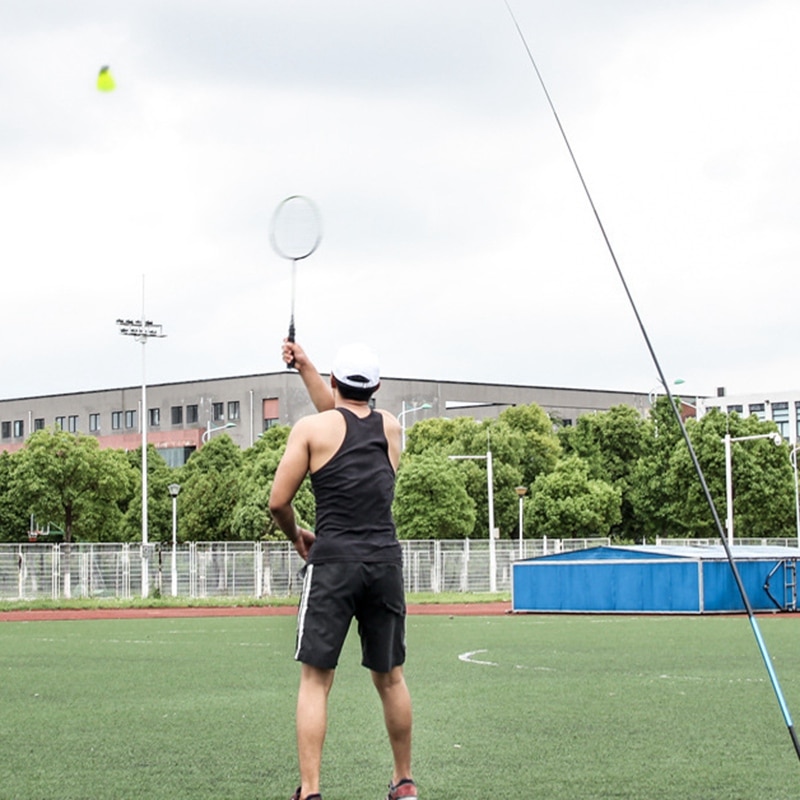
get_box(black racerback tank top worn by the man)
[308,408,402,564]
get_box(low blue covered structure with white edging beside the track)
[511,545,800,614]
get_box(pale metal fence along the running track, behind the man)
[0,538,609,600]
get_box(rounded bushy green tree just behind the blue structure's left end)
[525,456,621,539]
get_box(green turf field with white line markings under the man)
[0,616,800,800]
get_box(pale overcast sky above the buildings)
[0,0,800,398]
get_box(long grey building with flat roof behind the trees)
[0,370,649,466]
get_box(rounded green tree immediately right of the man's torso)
[393,452,475,539]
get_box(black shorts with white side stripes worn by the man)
[294,561,406,672]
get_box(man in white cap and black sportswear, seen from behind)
[269,342,417,800]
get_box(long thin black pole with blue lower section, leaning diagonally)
[503,0,800,759]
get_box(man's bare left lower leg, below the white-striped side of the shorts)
[296,664,334,798]
